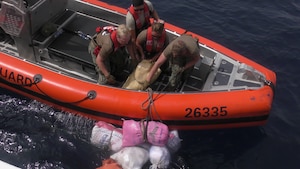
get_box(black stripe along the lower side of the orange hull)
[0,79,268,126]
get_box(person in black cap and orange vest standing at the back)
[126,0,159,61]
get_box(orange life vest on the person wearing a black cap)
[128,3,151,33]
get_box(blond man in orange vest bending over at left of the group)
[88,24,132,84]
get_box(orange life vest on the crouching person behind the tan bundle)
[146,26,166,53]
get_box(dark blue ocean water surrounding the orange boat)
[0,0,300,169]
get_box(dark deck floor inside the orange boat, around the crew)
[29,10,210,92]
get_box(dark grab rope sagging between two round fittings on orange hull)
[22,74,97,104]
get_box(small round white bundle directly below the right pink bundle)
[149,146,171,169]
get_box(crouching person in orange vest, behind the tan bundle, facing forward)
[136,20,169,62]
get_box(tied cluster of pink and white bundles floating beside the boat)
[91,120,181,169]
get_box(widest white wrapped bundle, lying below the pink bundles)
[110,147,149,169]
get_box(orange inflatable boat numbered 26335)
[0,0,276,130]
